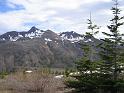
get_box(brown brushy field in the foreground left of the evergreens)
[0,70,65,93]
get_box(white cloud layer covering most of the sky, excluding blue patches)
[0,0,123,37]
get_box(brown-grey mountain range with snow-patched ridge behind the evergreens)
[0,26,99,71]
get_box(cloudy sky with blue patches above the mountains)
[0,0,124,37]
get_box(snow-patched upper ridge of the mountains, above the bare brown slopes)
[0,26,84,43]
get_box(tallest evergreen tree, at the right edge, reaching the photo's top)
[100,0,124,93]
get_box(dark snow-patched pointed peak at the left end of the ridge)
[0,26,44,41]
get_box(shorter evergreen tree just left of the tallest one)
[66,14,99,93]
